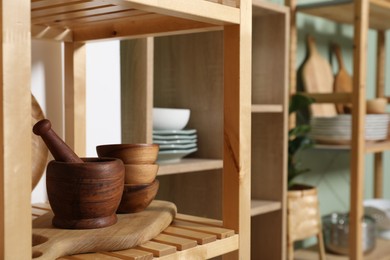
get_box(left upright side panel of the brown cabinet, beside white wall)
[120,38,154,143]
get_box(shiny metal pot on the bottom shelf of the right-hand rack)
[322,213,376,255]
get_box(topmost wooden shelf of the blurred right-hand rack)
[297,0,390,30]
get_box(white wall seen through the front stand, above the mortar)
[31,41,121,203]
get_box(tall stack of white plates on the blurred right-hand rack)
[310,114,389,144]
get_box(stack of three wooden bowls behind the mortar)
[96,144,159,213]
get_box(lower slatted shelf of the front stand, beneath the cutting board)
[32,203,238,260]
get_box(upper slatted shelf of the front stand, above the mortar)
[31,0,240,42]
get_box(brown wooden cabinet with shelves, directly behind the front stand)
[121,0,289,259]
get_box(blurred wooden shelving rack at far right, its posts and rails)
[287,0,390,260]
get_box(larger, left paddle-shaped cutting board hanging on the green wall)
[302,36,337,117]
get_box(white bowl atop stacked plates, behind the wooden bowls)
[153,108,198,162]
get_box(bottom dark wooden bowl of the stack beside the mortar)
[117,179,159,213]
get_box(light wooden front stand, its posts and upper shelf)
[0,0,252,259]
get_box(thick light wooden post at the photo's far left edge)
[0,0,32,259]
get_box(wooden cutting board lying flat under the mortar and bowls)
[33,200,176,260]
